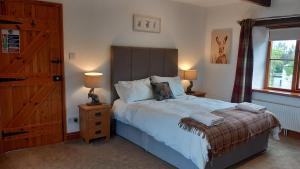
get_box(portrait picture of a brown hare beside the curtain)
[210,28,232,64]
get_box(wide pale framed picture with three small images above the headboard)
[133,14,161,33]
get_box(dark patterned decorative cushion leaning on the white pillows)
[151,82,175,101]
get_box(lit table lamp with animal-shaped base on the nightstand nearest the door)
[84,72,103,106]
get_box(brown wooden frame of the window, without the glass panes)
[264,40,300,93]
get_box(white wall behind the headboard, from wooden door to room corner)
[43,0,205,132]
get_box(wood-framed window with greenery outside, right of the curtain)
[265,40,300,92]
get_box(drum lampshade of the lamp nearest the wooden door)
[84,72,103,88]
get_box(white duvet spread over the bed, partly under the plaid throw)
[113,95,236,169]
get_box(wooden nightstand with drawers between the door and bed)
[79,104,111,143]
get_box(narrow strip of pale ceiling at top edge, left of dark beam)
[173,0,241,7]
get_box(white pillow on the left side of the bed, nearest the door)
[115,78,153,103]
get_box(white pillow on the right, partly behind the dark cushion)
[151,76,185,96]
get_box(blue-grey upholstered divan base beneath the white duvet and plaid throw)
[115,120,269,169]
